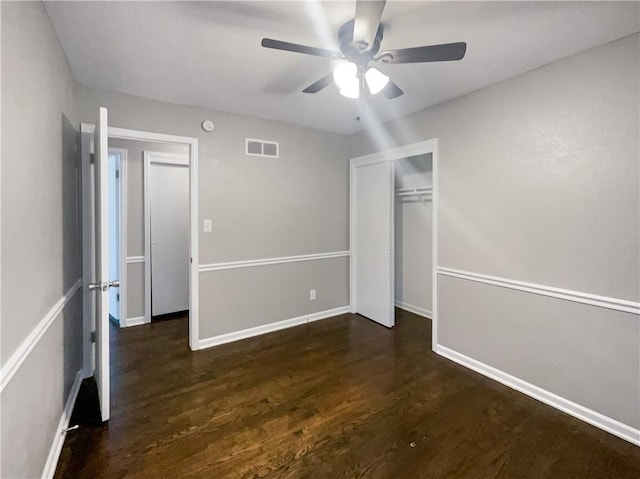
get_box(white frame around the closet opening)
[349,138,439,351]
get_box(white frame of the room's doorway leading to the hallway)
[80,123,200,377]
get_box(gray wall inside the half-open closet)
[394,154,433,316]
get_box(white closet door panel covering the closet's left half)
[351,161,395,328]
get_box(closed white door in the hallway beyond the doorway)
[147,162,189,316]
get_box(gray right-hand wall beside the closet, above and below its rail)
[352,34,640,428]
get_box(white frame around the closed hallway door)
[142,150,189,323]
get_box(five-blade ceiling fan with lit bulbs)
[262,0,467,99]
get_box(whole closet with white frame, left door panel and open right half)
[349,138,438,349]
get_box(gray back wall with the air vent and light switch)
[76,85,349,339]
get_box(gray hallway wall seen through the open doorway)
[109,139,189,318]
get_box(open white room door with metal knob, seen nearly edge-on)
[89,108,112,421]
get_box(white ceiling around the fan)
[46,0,640,133]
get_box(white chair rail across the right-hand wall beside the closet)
[438,268,640,315]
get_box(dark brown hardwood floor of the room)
[56,310,640,479]
